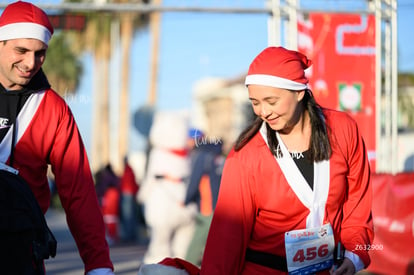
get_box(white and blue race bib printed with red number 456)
[285,223,335,274]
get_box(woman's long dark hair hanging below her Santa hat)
[234,89,332,161]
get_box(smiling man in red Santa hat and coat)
[0,1,113,275]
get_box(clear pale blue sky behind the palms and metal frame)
[60,0,414,154]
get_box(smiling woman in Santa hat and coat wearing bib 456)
[201,47,373,275]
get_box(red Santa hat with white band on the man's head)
[0,1,53,45]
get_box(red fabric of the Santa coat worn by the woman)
[201,111,373,275]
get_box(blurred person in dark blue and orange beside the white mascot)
[184,128,224,266]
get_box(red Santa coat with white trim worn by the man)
[0,90,113,271]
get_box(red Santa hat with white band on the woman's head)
[245,47,312,91]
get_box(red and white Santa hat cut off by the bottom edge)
[138,257,200,275]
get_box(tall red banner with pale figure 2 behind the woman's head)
[298,13,376,171]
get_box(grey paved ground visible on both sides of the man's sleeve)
[45,209,146,275]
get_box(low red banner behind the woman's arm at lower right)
[368,173,414,275]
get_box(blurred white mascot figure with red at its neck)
[138,111,197,263]
